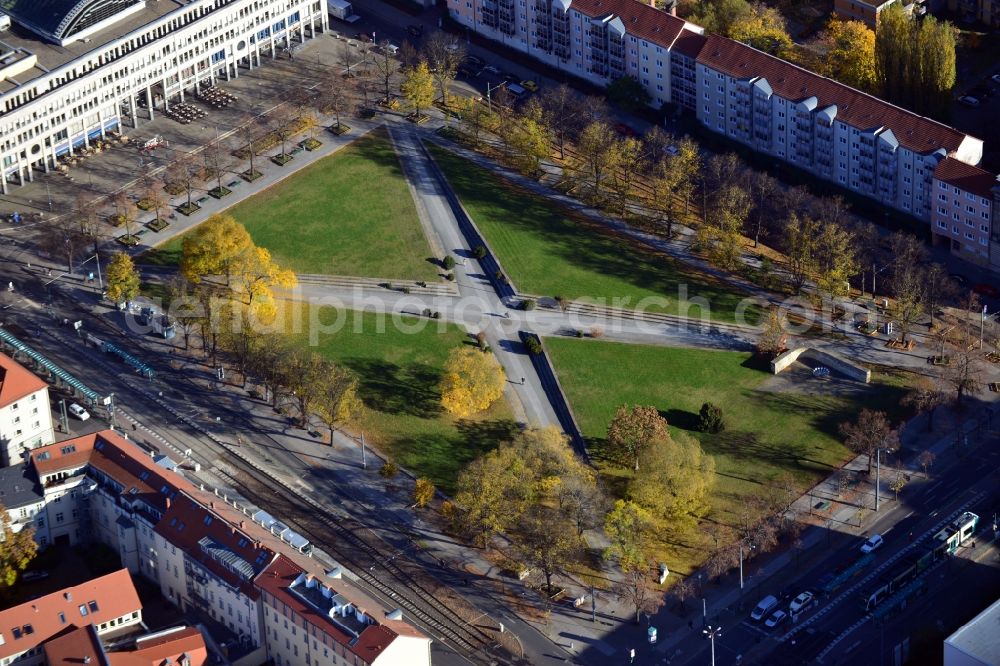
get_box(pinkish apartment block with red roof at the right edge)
[931,157,1000,270]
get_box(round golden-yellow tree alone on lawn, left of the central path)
[441,347,507,417]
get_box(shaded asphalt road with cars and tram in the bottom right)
[671,436,1000,666]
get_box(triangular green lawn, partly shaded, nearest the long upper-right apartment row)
[432,147,757,321]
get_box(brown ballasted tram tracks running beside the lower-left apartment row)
[216,456,504,661]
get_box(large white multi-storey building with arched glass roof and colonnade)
[0,0,329,194]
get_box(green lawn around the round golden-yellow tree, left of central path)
[284,306,516,492]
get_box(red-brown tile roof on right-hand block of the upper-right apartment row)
[698,35,966,153]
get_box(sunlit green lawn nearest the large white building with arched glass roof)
[139,130,438,280]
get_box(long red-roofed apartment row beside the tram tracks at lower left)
[19,431,430,666]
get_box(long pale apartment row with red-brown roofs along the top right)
[448,0,1000,263]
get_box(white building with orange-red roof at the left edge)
[0,354,55,466]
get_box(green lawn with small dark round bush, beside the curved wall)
[545,338,907,572]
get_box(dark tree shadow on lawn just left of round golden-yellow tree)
[343,358,442,419]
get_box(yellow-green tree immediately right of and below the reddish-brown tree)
[628,433,715,529]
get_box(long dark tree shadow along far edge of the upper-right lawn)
[438,152,744,313]
